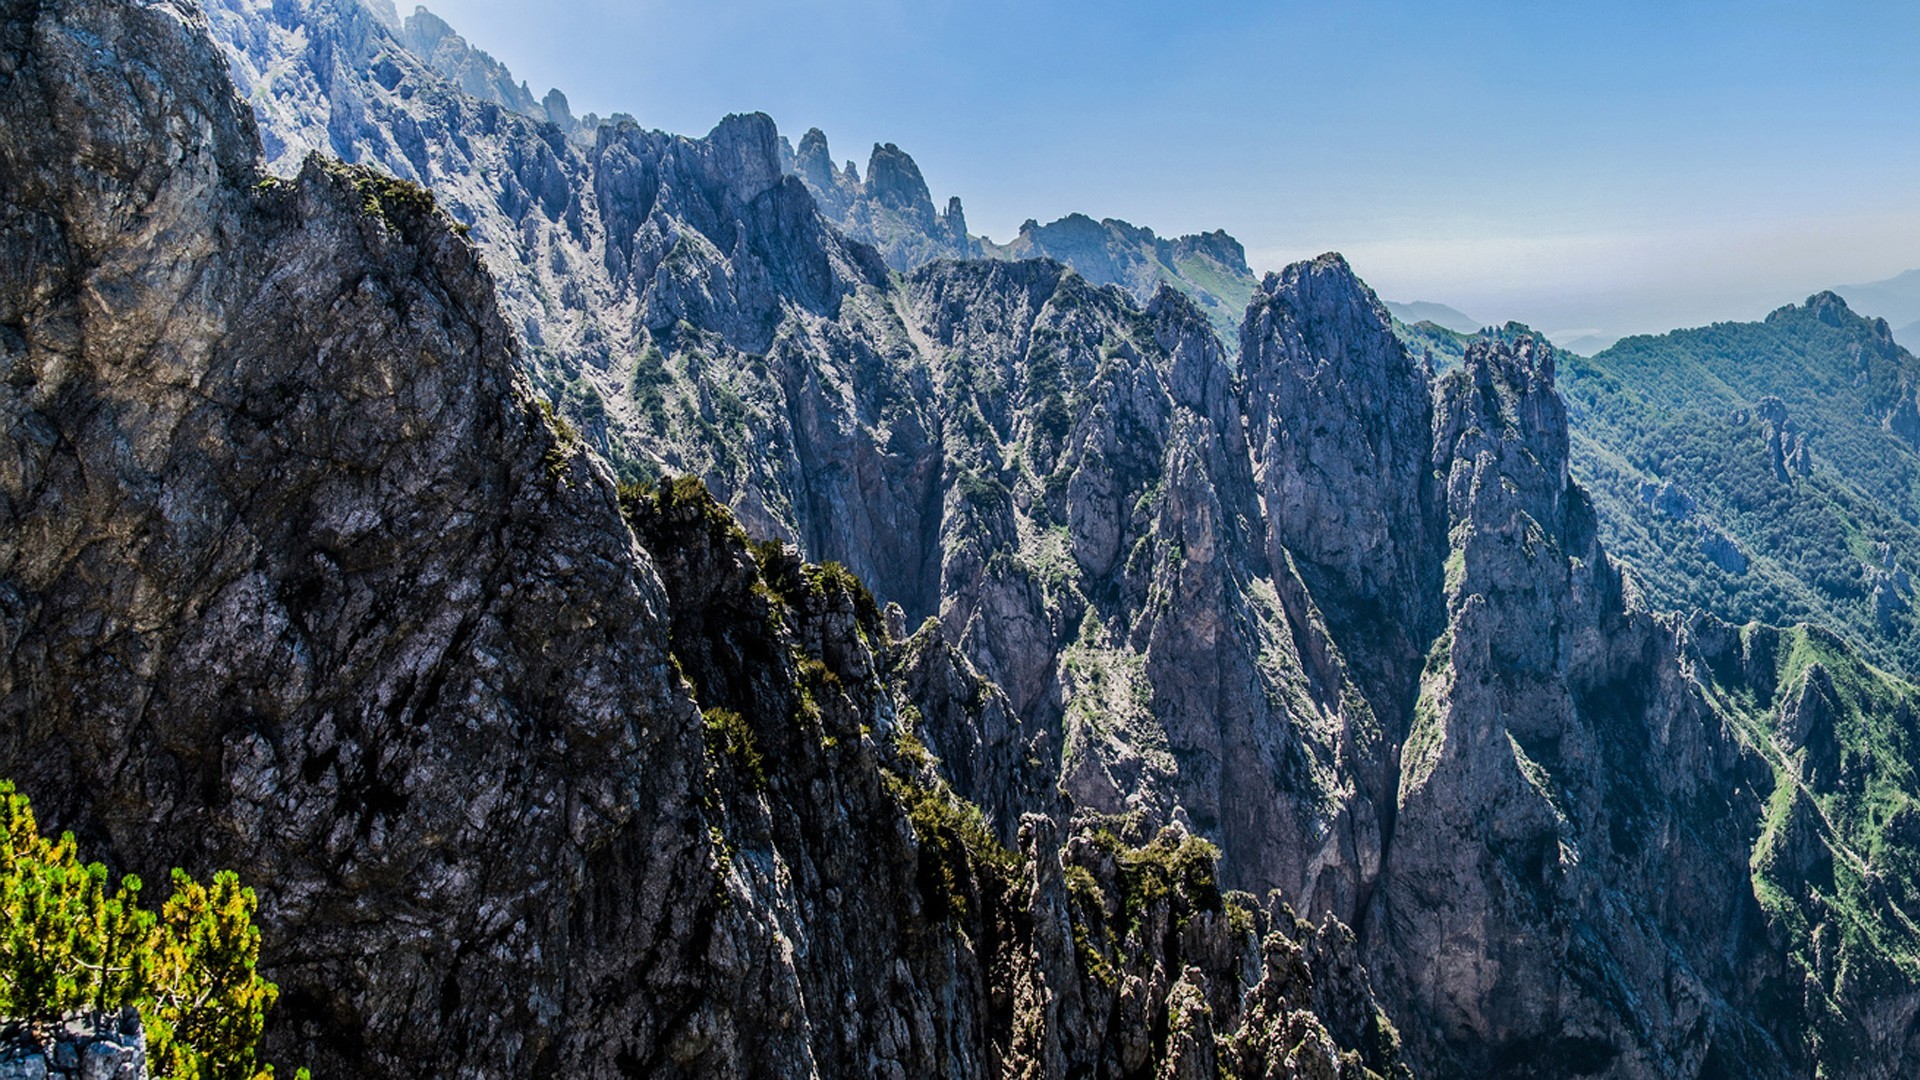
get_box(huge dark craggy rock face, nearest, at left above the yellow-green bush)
[0,4,707,1072]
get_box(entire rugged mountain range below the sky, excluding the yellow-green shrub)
[0,0,1920,1078]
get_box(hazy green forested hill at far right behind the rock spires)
[1559,292,1920,675]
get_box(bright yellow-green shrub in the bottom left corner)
[0,780,291,1080]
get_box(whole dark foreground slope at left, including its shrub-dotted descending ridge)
[0,0,1396,1076]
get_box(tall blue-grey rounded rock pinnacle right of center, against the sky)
[1240,256,1444,749]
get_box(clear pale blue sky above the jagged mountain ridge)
[401,0,1920,340]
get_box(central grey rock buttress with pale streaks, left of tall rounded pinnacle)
[890,261,1380,915]
